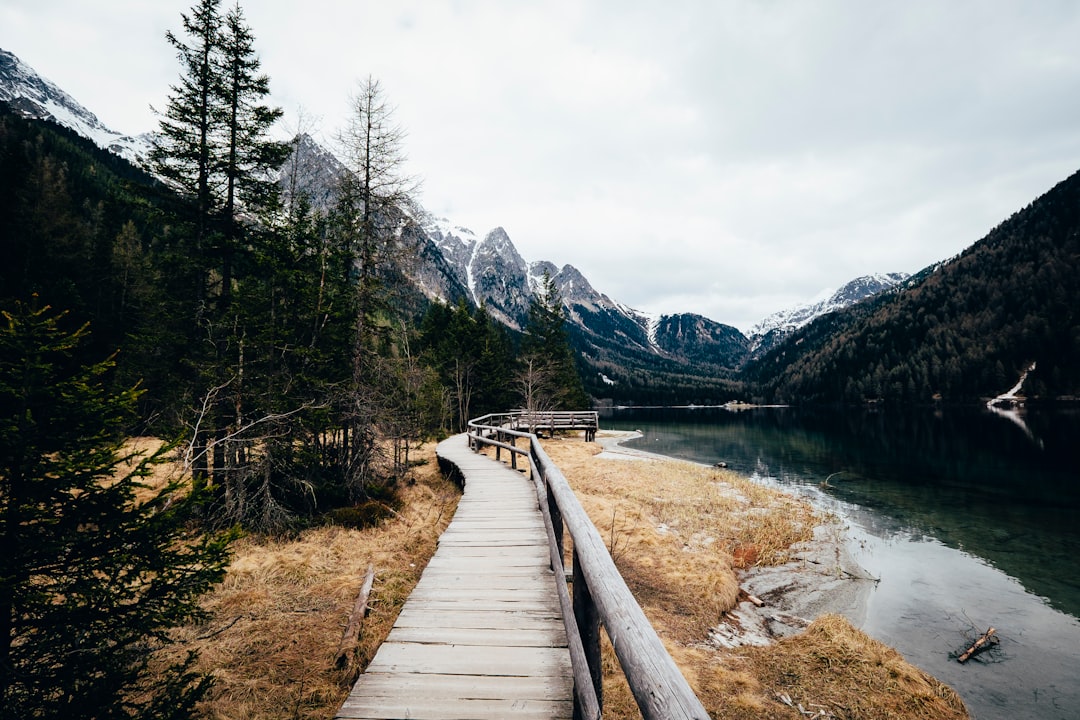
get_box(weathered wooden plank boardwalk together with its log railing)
[336,412,708,720]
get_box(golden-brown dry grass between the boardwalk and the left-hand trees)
[152,444,460,720]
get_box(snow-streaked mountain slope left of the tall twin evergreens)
[0,49,152,165]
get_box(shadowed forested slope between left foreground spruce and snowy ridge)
[0,103,198,415]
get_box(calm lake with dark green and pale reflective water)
[600,408,1080,720]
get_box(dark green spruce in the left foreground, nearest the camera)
[0,304,227,720]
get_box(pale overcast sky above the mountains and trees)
[0,0,1080,331]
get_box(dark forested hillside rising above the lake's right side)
[746,169,1080,403]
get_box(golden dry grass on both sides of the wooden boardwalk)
[154,438,967,720]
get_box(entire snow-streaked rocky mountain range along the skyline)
[0,50,906,397]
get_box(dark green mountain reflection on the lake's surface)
[605,408,1080,617]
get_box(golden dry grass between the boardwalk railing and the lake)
[544,438,968,720]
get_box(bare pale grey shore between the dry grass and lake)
[596,430,877,648]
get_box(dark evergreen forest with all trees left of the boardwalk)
[0,0,589,720]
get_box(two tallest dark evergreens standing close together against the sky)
[152,0,289,525]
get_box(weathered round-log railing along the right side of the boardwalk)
[469,412,708,720]
